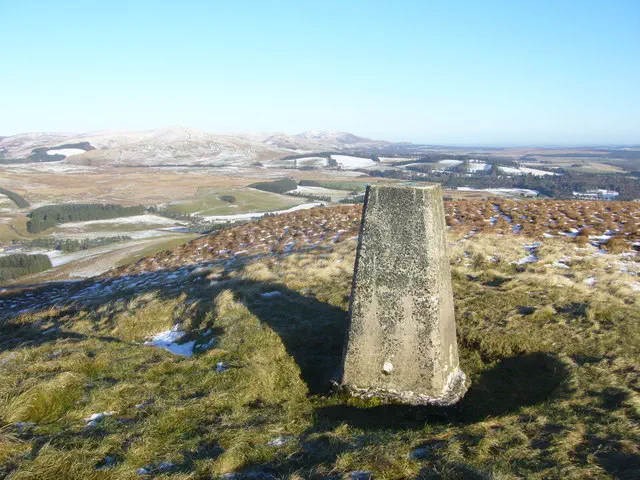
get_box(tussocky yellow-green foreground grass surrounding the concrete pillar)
[0,236,640,479]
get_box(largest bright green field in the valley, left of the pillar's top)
[166,188,305,216]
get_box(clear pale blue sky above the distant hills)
[0,0,640,145]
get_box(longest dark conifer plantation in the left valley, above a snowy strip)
[27,203,145,233]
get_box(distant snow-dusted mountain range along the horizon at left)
[0,127,419,166]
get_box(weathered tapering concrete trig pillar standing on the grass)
[342,185,466,405]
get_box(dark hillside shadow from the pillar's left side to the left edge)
[0,253,347,394]
